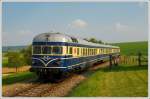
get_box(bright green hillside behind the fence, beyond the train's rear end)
[112,41,148,55]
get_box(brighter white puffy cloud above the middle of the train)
[71,19,88,28]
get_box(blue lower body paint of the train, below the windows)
[32,53,119,72]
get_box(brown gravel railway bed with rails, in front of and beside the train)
[3,62,108,97]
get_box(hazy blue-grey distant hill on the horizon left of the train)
[2,46,27,52]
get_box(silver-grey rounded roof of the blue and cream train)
[33,33,119,48]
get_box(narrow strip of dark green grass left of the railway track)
[2,72,36,85]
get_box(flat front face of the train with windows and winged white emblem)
[30,45,65,73]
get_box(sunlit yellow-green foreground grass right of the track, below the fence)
[69,65,148,97]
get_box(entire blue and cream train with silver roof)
[30,33,120,80]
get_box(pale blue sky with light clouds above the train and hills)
[2,2,148,46]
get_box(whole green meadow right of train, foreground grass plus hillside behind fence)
[68,41,148,97]
